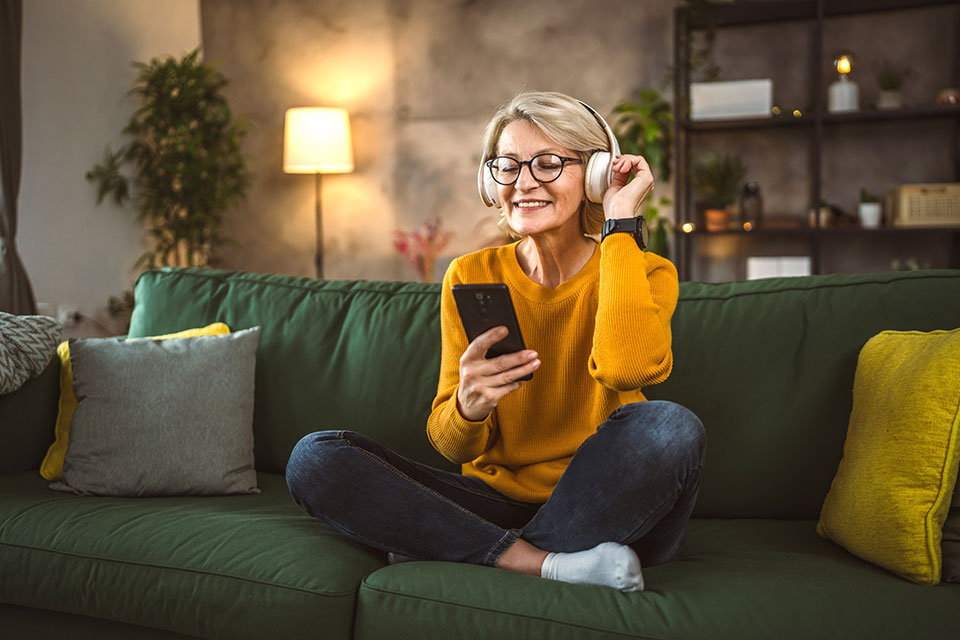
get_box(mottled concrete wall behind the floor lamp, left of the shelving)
[200,0,673,279]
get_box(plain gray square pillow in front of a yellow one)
[50,327,261,496]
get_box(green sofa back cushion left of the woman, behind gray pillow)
[129,267,456,473]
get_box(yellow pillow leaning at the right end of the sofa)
[817,329,960,585]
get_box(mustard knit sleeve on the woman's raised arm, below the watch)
[589,233,679,391]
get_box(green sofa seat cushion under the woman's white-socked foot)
[356,519,960,640]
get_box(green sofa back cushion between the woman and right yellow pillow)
[644,270,960,520]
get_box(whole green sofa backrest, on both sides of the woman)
[129,267,960,519]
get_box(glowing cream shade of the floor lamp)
[283,107,353,173]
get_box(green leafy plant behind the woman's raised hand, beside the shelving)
[612,89,674,259]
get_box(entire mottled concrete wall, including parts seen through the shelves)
[200,0,957,279]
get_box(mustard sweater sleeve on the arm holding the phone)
[427,260,497,464]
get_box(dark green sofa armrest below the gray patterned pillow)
[0,354,60,475]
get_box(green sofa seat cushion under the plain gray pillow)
[0,471,385,639]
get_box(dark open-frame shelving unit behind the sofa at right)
[674,0,960,280]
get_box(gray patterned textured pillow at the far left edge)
[0,311,63,396]
